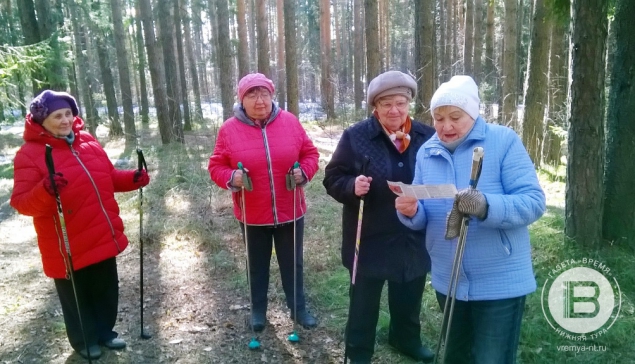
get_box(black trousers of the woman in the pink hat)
[240,217,306,314]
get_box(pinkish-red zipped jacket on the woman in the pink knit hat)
[208,106,319,225]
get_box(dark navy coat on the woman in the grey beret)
[323,116,434,282]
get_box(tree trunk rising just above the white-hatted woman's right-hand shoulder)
[502,0,518,131]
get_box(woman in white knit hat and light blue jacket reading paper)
[395,76,545,363]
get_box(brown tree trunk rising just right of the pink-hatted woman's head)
[284,0,300,116]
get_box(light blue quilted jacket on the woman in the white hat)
[398,116,545,301]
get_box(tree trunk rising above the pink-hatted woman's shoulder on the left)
[216,0,238,119]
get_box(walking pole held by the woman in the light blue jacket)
[434,147,484,363]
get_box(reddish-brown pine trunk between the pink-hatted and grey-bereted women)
[320,0,335,120]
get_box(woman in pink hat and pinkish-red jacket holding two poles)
[208,73,319,332]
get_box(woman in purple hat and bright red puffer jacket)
[11,90,150,359]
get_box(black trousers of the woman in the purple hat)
[54,258,119,350]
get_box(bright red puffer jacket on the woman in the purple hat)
[11,114,138,278]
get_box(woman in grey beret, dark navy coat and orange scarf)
[323,71,434,363]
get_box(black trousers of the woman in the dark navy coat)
[346,274,426,361]
